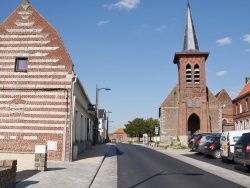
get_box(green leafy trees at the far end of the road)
[124,118,159,137]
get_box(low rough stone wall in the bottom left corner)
[0,160,17,187]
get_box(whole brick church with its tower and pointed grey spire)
[160,4,233,145]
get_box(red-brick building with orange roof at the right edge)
[233,77,250,130]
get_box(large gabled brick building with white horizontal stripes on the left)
[0,0,94,161]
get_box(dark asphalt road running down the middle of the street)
[116,144,242,188]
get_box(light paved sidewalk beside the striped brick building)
[16,144,110,188]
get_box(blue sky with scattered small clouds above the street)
[0,0,250,133]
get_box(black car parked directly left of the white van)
[201,136,221,159]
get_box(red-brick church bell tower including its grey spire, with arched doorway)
[174,3,210,136]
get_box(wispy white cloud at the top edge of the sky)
[103,0,140,10]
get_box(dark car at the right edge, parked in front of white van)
[234,132,250,169]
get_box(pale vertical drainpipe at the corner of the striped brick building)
[69,75,77,161]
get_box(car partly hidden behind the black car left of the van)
[194,133,221,153]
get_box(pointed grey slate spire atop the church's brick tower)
[183,3,199,51]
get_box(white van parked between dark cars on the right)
[220,129,250,160]
